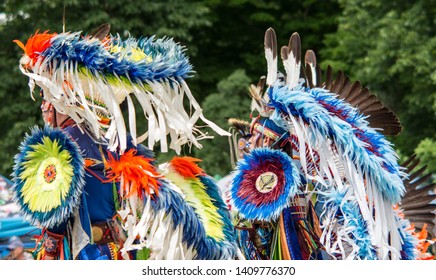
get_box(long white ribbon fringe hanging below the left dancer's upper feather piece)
[20,61,230,154]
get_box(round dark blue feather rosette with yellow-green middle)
[12,126,85,227]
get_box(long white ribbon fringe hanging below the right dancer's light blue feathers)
[288,115,401,259]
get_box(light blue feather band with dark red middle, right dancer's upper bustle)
[268,85,405,203]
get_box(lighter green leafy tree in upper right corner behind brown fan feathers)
[322,0,436,171]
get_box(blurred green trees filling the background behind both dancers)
[0,0,436,177]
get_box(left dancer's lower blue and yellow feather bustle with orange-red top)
[157,157,237,260]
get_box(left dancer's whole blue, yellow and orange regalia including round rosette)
[14,25,238,259]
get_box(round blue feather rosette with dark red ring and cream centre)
[230,148,300,221]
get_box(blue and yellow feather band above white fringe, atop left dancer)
[40,32,192,82]
